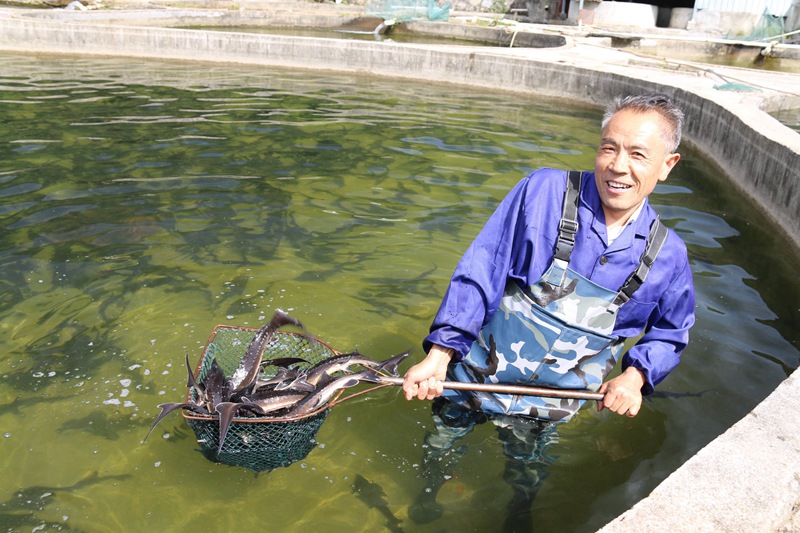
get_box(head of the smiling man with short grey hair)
[595,95,683,226]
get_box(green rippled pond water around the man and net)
[0,55,800,532]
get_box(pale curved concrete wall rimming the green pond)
[0,9,800,532]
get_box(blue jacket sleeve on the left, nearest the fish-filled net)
[423,178,530,359]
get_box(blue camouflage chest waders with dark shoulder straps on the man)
[444,171,667,421]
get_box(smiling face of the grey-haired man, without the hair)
[594,109,681,226]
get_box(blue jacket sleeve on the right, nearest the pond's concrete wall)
[622,243,695,394]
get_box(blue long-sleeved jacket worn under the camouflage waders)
[423,169,695,394]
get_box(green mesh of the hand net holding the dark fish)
[183,326,337,472]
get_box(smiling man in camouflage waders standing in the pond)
[403,95,694,524]
